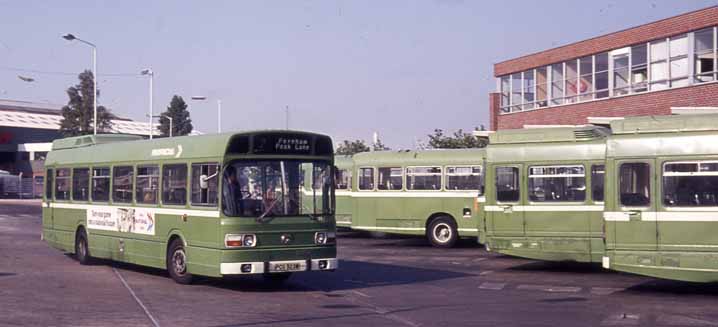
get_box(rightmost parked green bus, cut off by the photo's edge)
[603,115,718,282]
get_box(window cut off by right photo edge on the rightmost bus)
[663,161,718,207]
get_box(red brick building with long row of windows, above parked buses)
[489,6,718,130]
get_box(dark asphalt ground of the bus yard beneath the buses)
[0,200,718,327]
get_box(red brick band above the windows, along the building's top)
[494,6,718,77]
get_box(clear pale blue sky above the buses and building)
[0,0,717,147]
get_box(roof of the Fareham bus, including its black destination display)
[45,130,333,165]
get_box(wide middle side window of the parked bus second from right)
[528,165,586,202]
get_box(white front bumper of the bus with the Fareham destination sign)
[220,258,339,275]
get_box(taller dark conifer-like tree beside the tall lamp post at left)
[60,70,114,137]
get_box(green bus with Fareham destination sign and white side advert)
[42,131,338,283]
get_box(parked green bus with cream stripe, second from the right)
[485,126,609,262]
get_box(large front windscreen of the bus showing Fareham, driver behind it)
[222,160,334,218]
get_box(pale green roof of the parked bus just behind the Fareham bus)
[353,148,486,166]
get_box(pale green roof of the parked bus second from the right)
[489,125,611,145]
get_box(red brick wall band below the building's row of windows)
[489,82,718,131]
